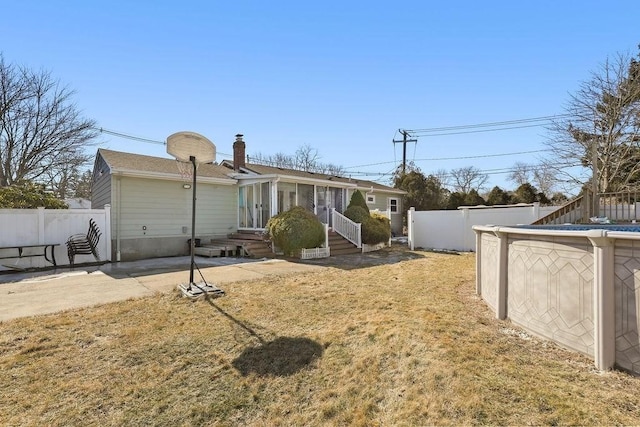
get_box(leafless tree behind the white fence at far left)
[0,55,97,187]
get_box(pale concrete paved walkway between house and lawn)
[0,257,324,321]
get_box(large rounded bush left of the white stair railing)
[265,206,325,256]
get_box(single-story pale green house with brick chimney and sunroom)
[92,135,404,261]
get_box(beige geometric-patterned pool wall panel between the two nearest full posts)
[507,236,593,355]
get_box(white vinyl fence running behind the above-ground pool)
[407,203,558,251]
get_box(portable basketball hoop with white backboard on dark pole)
[167,132,224,298]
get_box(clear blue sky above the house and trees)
[0,0,640,195]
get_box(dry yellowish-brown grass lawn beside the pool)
[0,252,640,426]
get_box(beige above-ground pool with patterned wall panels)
[473,224,640,374]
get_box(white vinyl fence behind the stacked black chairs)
[0,205,111,268]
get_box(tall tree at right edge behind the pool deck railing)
[547,50,640,192]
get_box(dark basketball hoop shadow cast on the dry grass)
[205,296,324,377]
